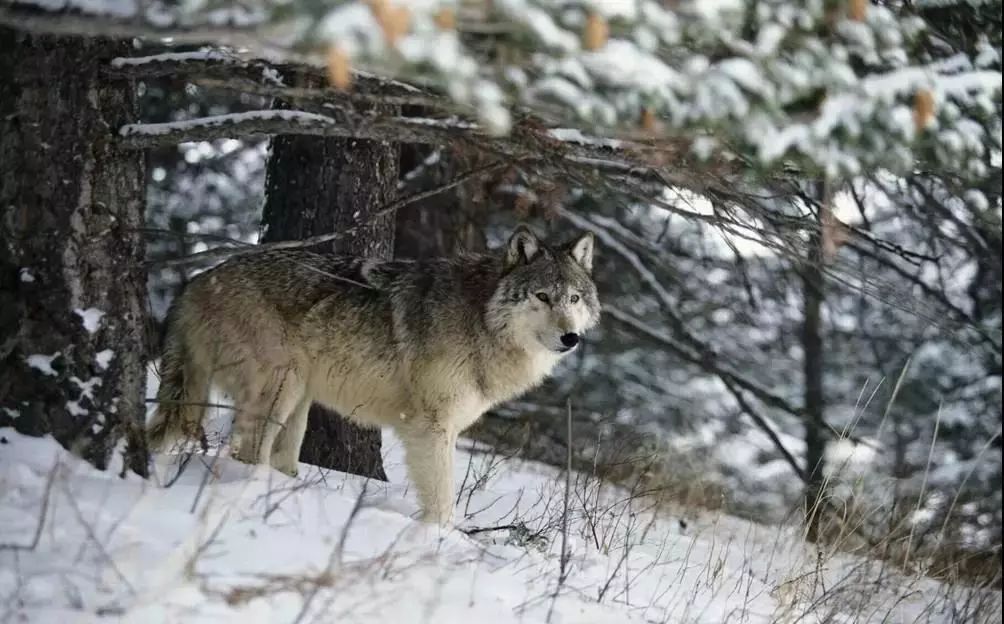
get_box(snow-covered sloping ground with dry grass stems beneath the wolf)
[0,423,1000,624]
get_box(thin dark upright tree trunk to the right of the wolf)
[801,196,828,542]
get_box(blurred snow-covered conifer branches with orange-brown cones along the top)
[0,0,1001,179]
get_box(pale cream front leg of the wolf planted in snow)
[399,422,457,526]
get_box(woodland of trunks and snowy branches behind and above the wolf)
[0,0,1002,587]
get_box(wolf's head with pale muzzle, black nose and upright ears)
[488,226,599,354]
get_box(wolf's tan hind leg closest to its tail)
[234,366,305,464]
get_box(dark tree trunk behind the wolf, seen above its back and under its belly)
[262,84,398,481]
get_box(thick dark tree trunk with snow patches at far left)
[0,27,148,475]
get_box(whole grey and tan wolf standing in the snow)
[148,226,600,525]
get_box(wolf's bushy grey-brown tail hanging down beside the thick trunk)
[147,314,207,451]
